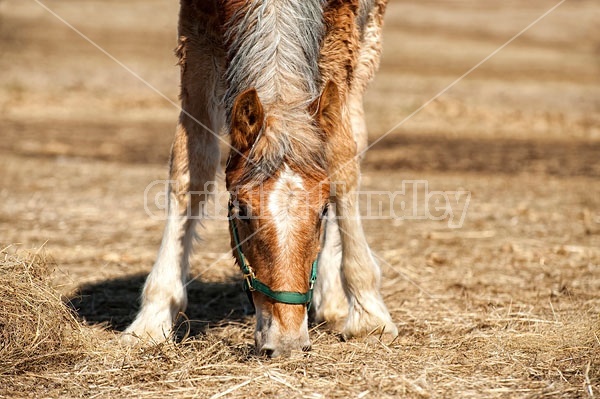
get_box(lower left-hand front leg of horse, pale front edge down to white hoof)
[122,115,219,344]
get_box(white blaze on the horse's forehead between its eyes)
[269,165,304,255]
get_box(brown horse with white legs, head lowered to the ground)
[123,0,398,356]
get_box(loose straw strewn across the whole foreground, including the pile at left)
[0,245,600,398]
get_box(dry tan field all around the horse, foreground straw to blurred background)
[0,0,600,398]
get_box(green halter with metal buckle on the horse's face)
[229,202,318,309]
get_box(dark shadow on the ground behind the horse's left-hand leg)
[67,274,254,338]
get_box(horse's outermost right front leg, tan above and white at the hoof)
[317,82,398,337]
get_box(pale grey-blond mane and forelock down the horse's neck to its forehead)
[224,0,326,186]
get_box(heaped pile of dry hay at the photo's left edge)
[0,248,84,376]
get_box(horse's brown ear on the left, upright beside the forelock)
[231,89,265,152]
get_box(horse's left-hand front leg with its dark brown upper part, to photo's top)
[122,2,224,343]
